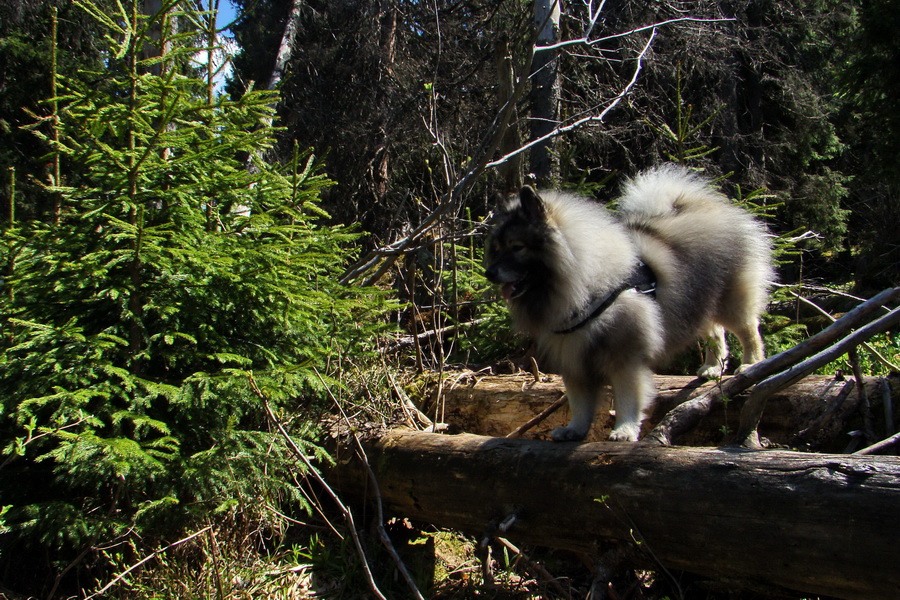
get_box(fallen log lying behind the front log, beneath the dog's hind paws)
[424,373,900,452]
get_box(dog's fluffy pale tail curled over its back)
[618,164,723,217]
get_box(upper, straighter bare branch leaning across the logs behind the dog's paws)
[643,287,900,446]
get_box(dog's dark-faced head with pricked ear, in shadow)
[485,186,552,302]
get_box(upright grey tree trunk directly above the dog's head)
[531,0,561,185]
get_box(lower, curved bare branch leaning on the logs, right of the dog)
[737,308,900,448]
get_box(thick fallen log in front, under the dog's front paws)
[330,430,900,600]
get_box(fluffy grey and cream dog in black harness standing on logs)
[486,165,774,441]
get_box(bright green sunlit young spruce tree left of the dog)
[0,2,386,592]
